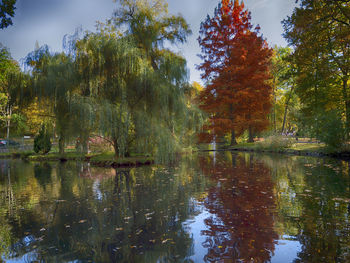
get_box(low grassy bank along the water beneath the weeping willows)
[0,151,154,167]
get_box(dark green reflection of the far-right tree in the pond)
[297,159,350,262]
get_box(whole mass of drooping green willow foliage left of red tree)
[18,0,201,161]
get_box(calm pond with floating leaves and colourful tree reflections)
[0,152,350,263]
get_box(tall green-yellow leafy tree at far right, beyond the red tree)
[283,0,350,146]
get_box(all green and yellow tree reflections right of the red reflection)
[262,156,350,262]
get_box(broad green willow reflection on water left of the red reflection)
[0,158,208,262]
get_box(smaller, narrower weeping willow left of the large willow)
[26,46,79,154]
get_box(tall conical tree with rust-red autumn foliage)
[198,0,272,145]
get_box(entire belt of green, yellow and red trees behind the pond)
[0,0,350,162]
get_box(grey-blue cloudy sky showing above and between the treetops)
[0,0,296,83]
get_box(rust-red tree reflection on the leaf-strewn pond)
[201,155,278,262]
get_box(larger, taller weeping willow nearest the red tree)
[76,1,204,161]
